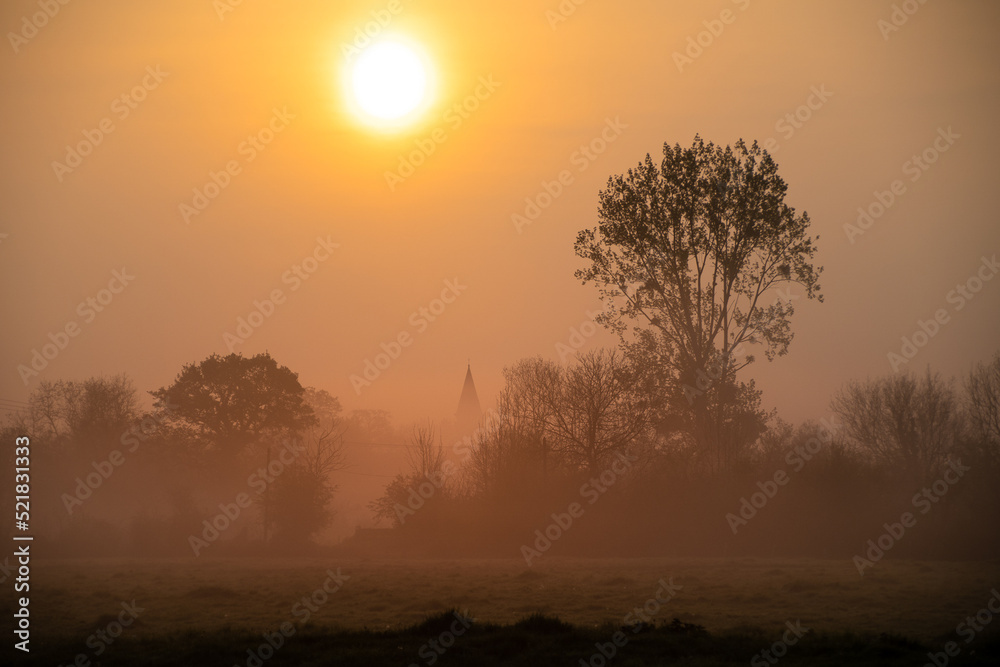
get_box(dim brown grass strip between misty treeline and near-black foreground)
[32,558,1000,642]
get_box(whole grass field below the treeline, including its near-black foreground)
[19,558,1000,665]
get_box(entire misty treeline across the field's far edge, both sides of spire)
[4,351,1000,564]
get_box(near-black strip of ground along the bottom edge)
[17,613,1000,667]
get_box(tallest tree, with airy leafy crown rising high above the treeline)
[575,136,822,467]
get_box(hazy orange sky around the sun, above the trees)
[0,0,1000,421]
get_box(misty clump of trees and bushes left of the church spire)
[3,354,366,556]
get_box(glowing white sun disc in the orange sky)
[350,38,431,127]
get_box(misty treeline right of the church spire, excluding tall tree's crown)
[368,353,1000,562]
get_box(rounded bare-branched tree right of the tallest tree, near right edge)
[832,370,962,479]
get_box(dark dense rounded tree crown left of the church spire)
[150,353,316,456]
